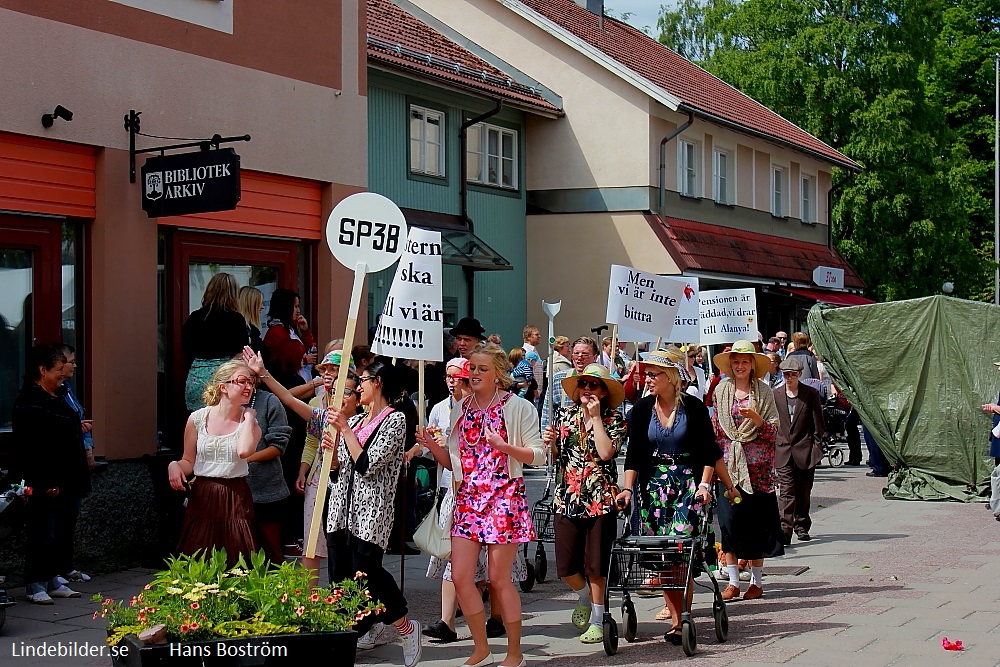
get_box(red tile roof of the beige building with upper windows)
[519,0,860,169]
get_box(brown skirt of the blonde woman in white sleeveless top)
[177,477,261,567]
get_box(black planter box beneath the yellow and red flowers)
[112,630,358,667]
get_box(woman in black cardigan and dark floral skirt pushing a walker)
[618,350,738,644]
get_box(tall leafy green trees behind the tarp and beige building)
[659,0,1000,300]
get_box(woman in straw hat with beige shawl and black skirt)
[712,340,785,600]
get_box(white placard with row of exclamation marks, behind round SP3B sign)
[372,227,444,361]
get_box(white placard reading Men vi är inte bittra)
[607,264,684,340]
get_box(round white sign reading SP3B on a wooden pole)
[326,192,407,273]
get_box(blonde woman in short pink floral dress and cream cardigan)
[420,343,545,667]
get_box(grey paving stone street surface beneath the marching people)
[0,460,1000,667]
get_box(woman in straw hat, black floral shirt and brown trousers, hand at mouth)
[543,364,625,644]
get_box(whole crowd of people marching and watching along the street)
[14,273,928,667]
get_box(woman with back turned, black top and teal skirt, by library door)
[181,273,249,410]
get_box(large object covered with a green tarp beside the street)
[809,296,1000,502]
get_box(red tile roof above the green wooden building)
[367,0,562,115]
